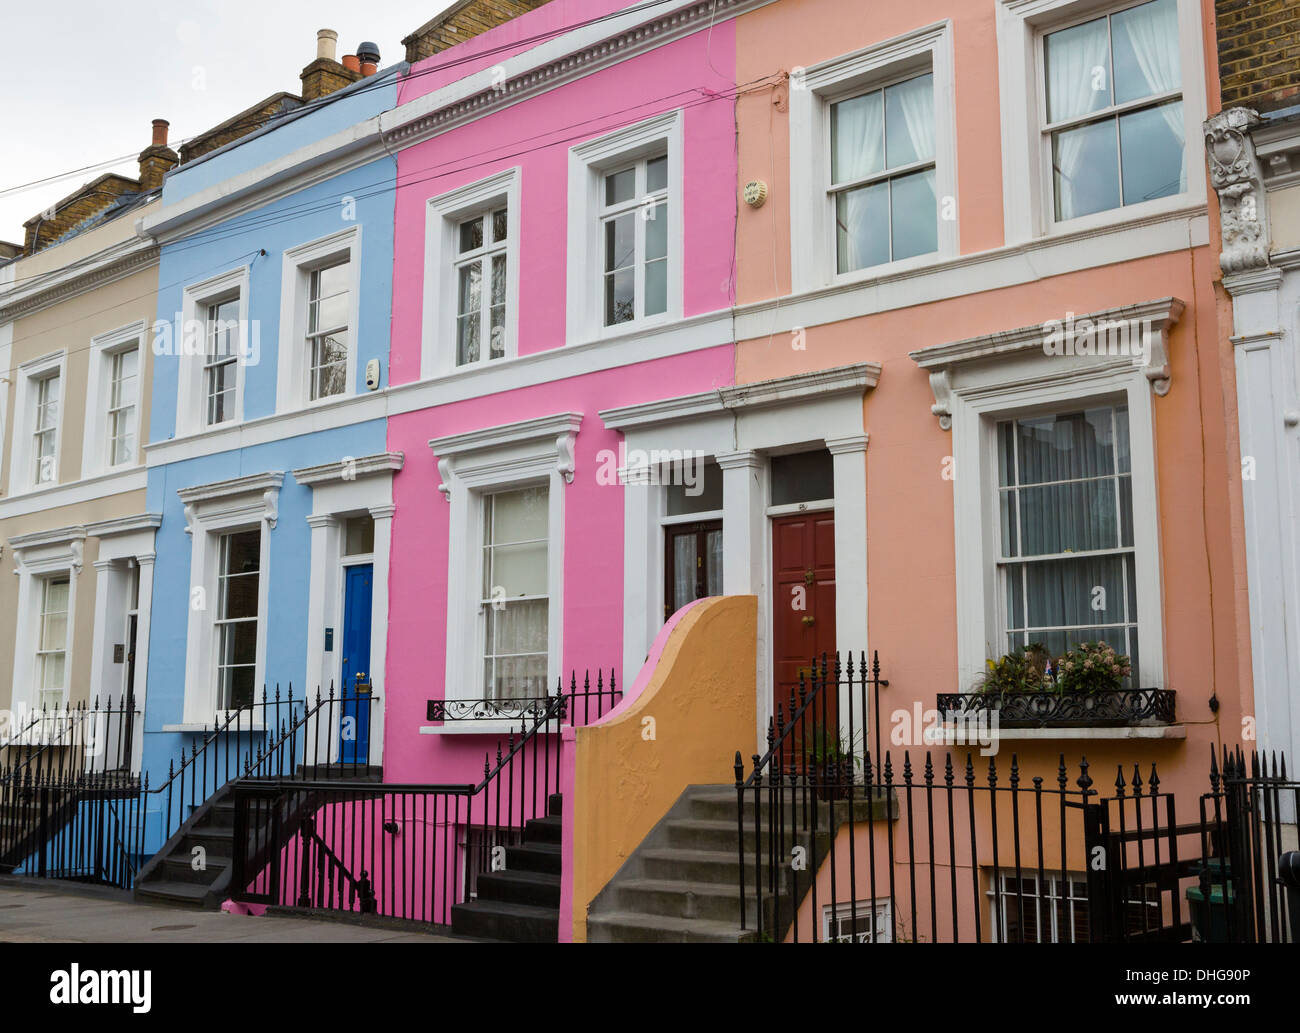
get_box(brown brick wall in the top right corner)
[1214,0,1300,112]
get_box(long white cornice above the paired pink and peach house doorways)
[598,363,880,430]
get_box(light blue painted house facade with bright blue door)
[138,65,404,847]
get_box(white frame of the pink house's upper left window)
[420,168,523,377]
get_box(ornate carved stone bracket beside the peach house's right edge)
[1205,108,1269,273]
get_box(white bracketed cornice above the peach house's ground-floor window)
[909,298,1183,430]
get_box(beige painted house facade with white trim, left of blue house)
[0,195,159,764]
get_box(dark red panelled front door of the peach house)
[772,512,835,713]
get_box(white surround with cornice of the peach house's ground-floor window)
[911,298,1183,691]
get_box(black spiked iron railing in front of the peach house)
[735,659,1300,942]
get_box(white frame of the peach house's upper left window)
[790,21,959,294]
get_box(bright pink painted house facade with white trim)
[385,0,737,782]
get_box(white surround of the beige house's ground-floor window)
[9,526,86,720]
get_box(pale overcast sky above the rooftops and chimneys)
[0,0,451,243]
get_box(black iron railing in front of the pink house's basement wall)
[230,673,621,925]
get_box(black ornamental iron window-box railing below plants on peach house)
[937,689,1175,728]
